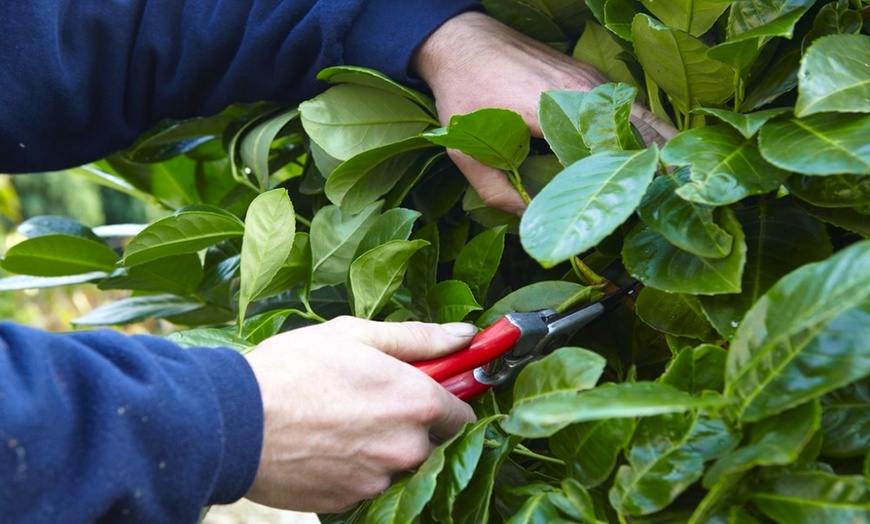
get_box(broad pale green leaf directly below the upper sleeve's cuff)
[299,84,438,160]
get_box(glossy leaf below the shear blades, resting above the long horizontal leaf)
[514,347,607,404]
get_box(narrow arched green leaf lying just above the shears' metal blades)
[477,280,599,327]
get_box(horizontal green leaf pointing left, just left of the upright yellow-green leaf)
[121,211,245,266]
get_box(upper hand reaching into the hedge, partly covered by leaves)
[413,12,676,214]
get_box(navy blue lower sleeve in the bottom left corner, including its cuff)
[0,323,263,524]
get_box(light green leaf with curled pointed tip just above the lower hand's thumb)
[348,240,428,318]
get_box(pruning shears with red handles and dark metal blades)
[413,282,636,400]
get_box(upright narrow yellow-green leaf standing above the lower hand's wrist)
[239,189,296,321]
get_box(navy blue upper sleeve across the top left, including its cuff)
[0,0,480,173]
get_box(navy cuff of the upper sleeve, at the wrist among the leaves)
[344,0,483,87]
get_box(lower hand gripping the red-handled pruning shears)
[247,317,476,512]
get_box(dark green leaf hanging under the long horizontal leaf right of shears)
[550,418,636,488]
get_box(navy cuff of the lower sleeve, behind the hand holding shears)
[188,348,263,504]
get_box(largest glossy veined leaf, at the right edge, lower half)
[725,241,870,422]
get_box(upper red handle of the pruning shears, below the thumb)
[413,317,522,383]
